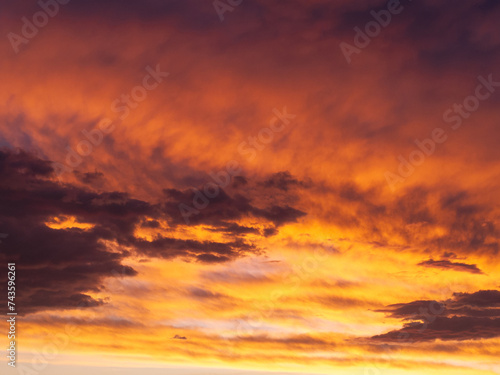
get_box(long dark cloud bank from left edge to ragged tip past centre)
[0,150,304,314]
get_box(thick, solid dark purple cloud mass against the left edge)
[0,151,152,314]
